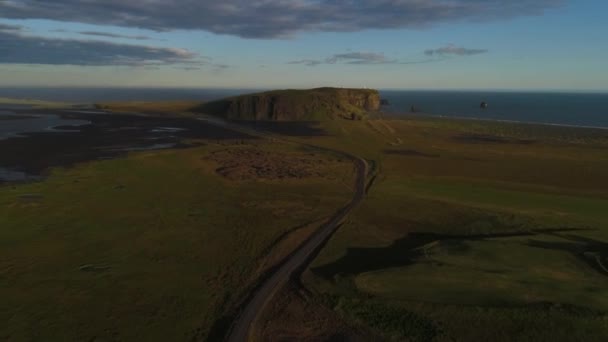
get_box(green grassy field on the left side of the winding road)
[0,141,354,341]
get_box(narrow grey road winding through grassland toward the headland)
[196,117,368,342]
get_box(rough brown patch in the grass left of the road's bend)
[207,148,342,180]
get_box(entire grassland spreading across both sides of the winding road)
[0,97,608,341]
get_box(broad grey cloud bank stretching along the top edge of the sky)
[0,0,566,38]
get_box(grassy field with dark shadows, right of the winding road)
[304,118,608,341]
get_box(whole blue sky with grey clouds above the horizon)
[0,0,608,92]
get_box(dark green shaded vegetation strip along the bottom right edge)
[322,294,608,341]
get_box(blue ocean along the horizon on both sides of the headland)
[0,88,608,128]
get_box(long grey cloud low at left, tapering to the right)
[0,31,202,66]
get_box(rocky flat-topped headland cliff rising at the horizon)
[199,88,380,121]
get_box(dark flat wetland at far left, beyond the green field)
[0,111,253,183]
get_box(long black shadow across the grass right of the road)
[312,228,582,279]
